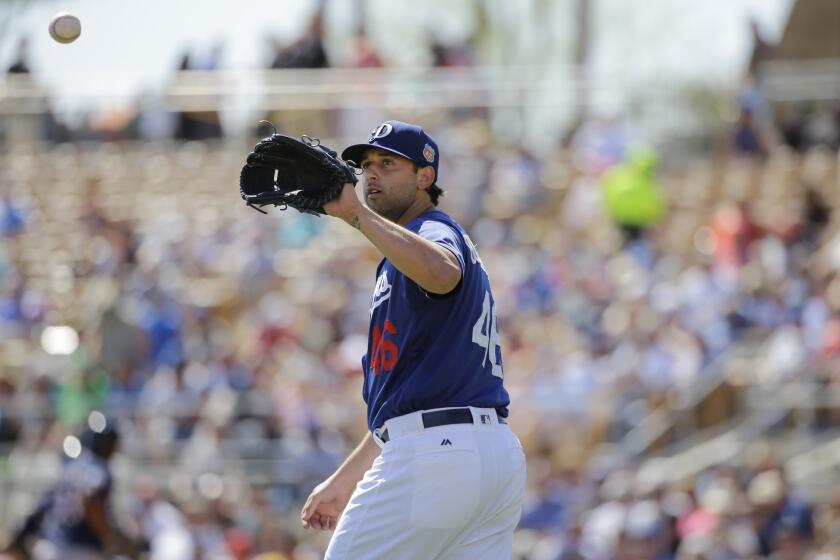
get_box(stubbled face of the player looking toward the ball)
[361,149,418,222]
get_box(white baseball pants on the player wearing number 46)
[325,408,525,560]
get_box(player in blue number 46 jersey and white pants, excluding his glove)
[301,120,525,560]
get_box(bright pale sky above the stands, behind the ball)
[0,0,792,112]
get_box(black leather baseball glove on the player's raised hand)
[239,126,356,215]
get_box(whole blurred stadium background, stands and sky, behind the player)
[0,0,840,560]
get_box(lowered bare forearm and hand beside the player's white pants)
[300,432,381,531]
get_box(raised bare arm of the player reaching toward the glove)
[328,185,461,294]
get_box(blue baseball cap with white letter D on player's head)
[341,120,440,182]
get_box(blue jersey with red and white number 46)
[362,210,510,430]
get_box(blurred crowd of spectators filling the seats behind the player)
[0,97,840,560]
